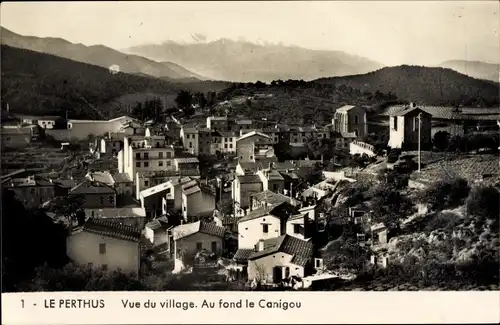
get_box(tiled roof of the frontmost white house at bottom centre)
[248,235,313,266]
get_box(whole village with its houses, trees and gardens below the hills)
[1,103,500,290]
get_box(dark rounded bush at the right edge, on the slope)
[466,186,500,221]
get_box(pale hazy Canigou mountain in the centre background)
[123,39,381,82]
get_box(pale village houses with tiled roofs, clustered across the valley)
[2,105,496,283]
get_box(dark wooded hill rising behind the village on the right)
[215,66,499,125]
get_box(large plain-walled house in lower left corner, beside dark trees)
[66,218,141,274]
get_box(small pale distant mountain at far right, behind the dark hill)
[438,60,500,82]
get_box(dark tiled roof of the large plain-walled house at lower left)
[83,218,141,242]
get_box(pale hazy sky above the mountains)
[0,0,500,65]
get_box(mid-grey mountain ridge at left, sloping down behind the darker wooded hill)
[0,28,207,80]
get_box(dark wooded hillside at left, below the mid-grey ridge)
[1,45,227,118]
